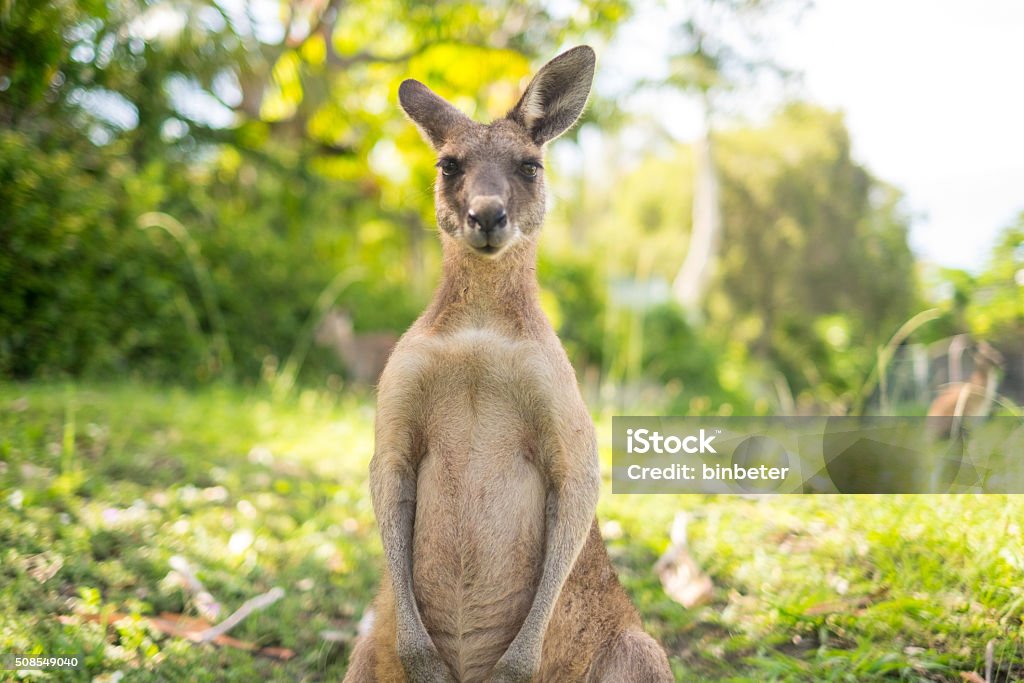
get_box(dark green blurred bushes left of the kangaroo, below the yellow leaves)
[0,126,418,383]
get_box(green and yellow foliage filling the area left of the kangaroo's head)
[0,0,628,383]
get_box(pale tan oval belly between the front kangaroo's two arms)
[413,335,545,681]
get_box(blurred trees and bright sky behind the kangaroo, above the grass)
[0,0,1024,414]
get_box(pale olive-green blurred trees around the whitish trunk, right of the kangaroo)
[561,103,919,413]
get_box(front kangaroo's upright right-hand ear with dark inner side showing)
[508,45,597,144]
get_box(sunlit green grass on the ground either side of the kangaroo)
[0,384,1024,681]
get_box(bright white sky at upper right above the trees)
[598,0,1024,270]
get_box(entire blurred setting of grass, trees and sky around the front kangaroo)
[0,0,1024,683]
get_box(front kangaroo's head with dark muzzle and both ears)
[398,45,595,257]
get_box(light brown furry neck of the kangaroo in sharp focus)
[424,233,546,333]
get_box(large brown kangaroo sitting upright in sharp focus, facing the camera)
[345,46,673,683]
